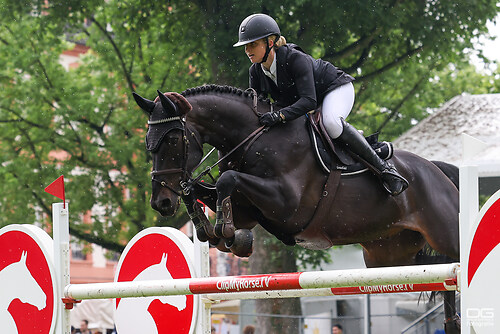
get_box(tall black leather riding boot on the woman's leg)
[338,119,408,196]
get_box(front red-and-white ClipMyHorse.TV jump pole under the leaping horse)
[64,263,460,300]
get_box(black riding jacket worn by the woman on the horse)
[249,44,354,121]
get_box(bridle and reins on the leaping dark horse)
[148,88,268,197]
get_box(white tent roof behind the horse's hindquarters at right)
[394,94,500,192]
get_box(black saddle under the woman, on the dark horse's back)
[307,111,394,175]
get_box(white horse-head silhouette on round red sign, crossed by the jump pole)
[115,253,187,334]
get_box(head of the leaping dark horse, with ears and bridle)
[133,91,203,216]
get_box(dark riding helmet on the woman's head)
[233,14,281,63]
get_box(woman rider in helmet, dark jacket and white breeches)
[234,14,408,195]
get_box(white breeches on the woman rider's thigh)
[321,82,354,139]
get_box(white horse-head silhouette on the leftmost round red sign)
[0,252,47,333]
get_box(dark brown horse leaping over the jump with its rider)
[133,85,459,333]
